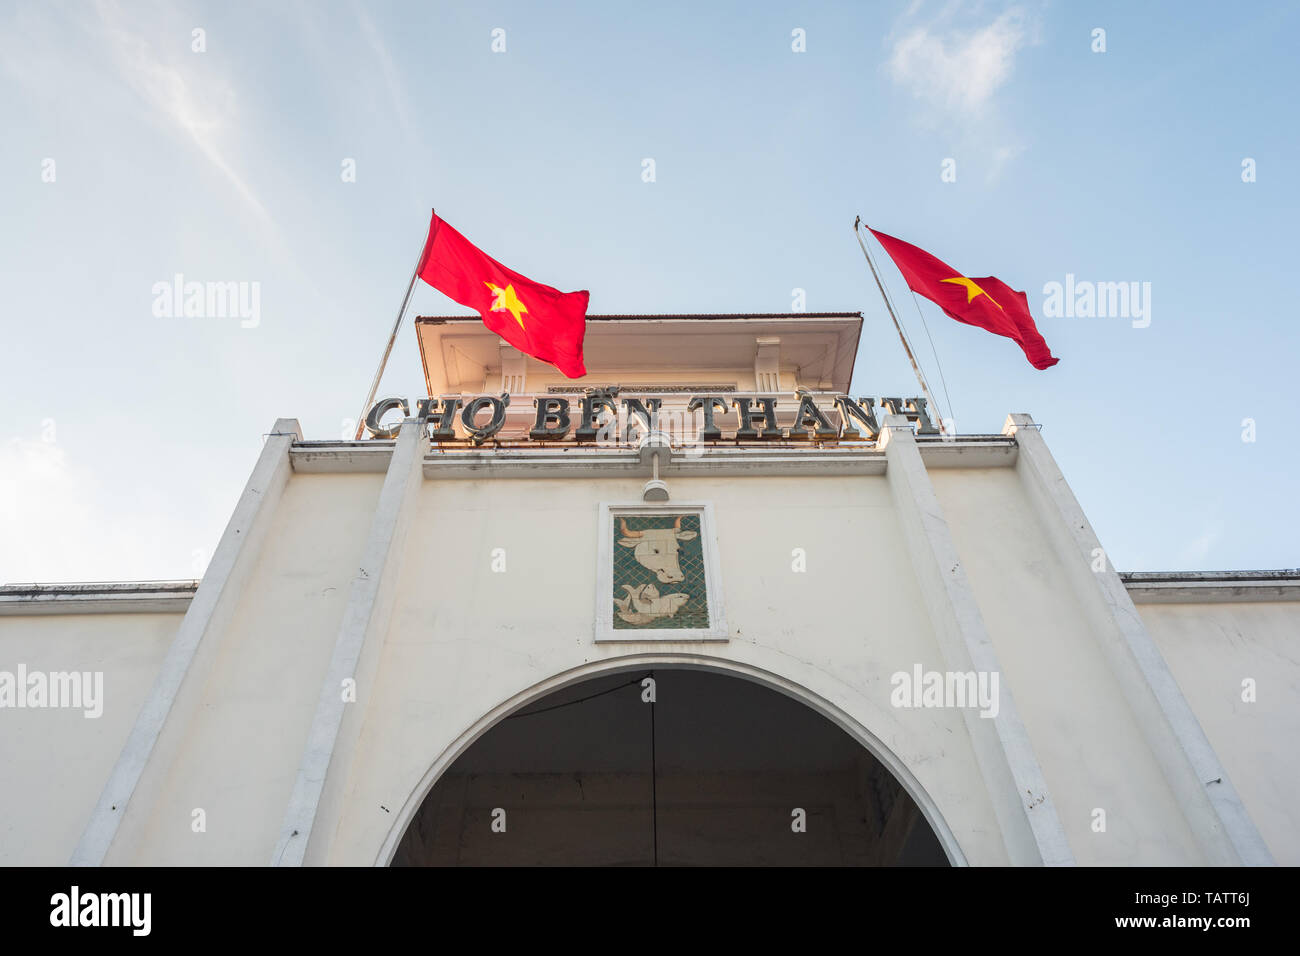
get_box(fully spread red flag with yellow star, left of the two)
[419,213,588,378]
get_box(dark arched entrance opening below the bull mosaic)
[393,667,949,866]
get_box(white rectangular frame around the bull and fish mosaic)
[595,501,729,644]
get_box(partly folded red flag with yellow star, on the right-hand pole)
[867,226,1061,369]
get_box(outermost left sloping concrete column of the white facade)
[70,419,303,866]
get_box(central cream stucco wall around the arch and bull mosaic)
[325,477,1006,864]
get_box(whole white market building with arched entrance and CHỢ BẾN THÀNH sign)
[0,313,1300,865]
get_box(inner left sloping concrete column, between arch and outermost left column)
[270,419,428,866]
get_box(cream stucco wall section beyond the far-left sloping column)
[0,614,181,866]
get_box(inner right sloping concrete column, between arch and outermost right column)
[880,415,1074,866]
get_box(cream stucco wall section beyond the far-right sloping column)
[1138,601,1300,866]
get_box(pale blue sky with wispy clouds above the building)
[0,0,1300,583]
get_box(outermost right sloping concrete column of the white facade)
[1002,414,1273,866]
